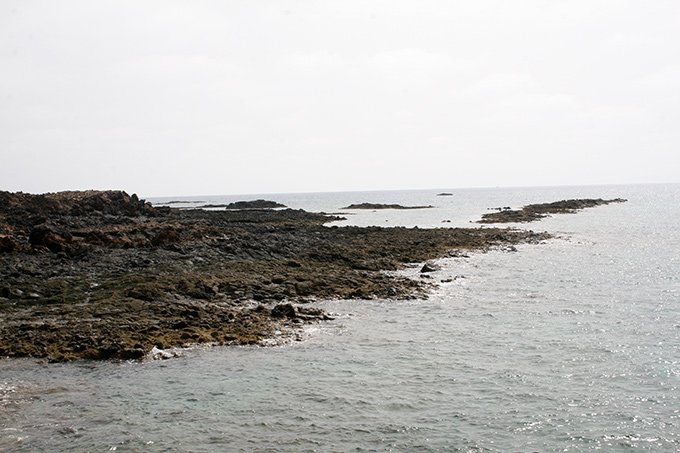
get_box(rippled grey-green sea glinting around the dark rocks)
[0,184,680,452]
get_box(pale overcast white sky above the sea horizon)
[0,0,680,197]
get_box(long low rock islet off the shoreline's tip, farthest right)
[477,198,627,223]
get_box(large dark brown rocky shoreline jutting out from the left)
[0,191,548,362]
